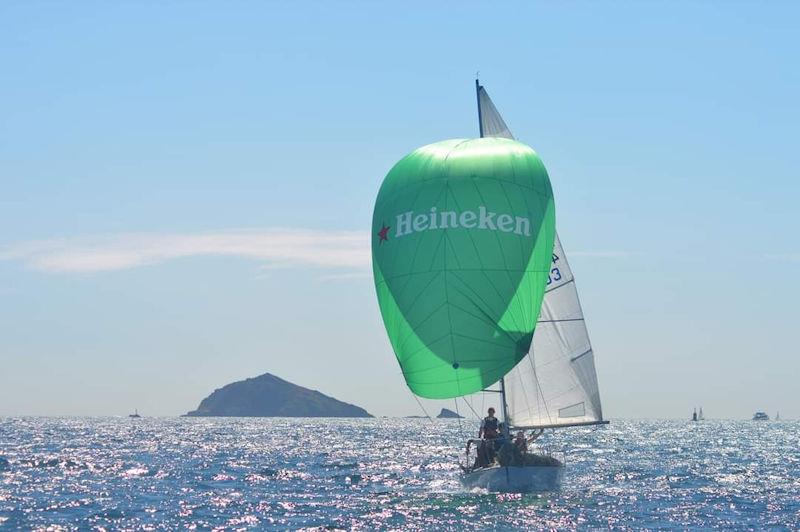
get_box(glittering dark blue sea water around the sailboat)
[0,418,800,530]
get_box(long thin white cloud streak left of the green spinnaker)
[0,229,370,273]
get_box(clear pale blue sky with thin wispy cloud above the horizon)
[0,1,800,419]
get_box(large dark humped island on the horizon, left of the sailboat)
[186,373,372,417]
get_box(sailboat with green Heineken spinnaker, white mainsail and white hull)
[372,80,607,492]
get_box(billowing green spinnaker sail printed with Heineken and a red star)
[372,138,555,399]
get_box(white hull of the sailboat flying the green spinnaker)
[461,466,564,493]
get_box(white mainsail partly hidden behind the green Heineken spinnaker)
[477,84,603,428]
